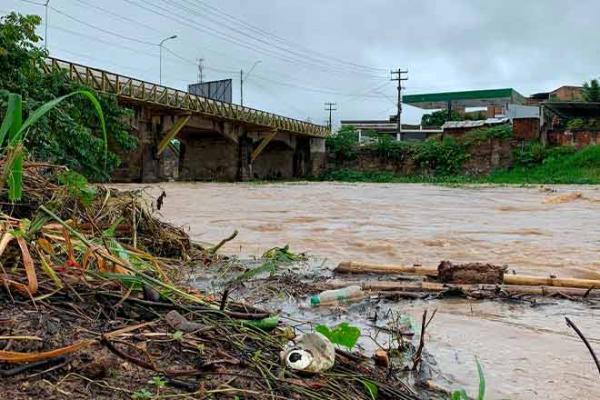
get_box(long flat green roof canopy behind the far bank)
[402,88,525,110]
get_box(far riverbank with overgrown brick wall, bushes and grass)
[324,128,600,184]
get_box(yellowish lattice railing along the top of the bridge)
[45,57,329,137]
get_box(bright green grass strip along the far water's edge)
[319,145,600,184]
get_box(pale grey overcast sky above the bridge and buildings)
[0,0,600,123]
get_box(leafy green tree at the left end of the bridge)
[0,13,137,181]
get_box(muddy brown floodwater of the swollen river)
[123,183,600,400]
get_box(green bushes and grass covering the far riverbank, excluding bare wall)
[319,125,600,184]
